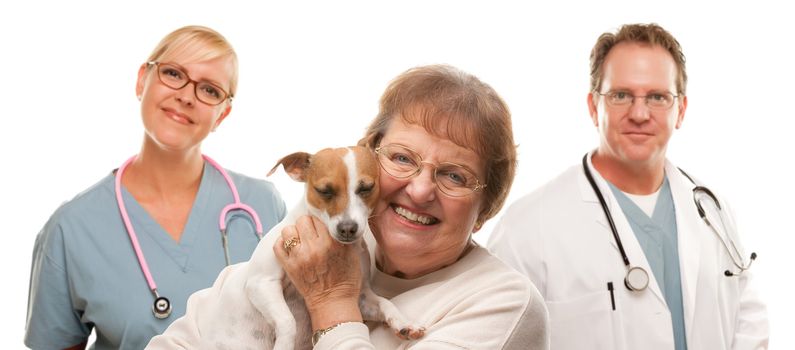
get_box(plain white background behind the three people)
[0,1,795,349]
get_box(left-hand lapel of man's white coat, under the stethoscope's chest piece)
[580,153,667,305]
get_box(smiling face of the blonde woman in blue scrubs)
[136,55,234,151]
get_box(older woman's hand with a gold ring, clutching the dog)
[273,216,362,329]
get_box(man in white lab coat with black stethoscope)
[488,24,768,350]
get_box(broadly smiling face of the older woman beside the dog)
[371,118,485,278]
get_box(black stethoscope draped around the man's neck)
[582,153,756,291]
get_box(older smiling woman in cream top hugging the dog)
[274,66,548,349]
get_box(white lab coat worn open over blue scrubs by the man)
[489,155,768,350]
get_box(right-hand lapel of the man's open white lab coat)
[665,162,705,334]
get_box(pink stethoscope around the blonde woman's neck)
[116,155,262,319]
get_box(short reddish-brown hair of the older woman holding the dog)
[359,65,517,227]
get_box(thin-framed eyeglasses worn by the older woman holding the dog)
[375,144,486,197]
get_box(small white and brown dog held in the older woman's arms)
[158,146,425,350]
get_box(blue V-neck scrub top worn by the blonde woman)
[25,162,286,349]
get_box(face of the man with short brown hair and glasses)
[588,42,687,166]
